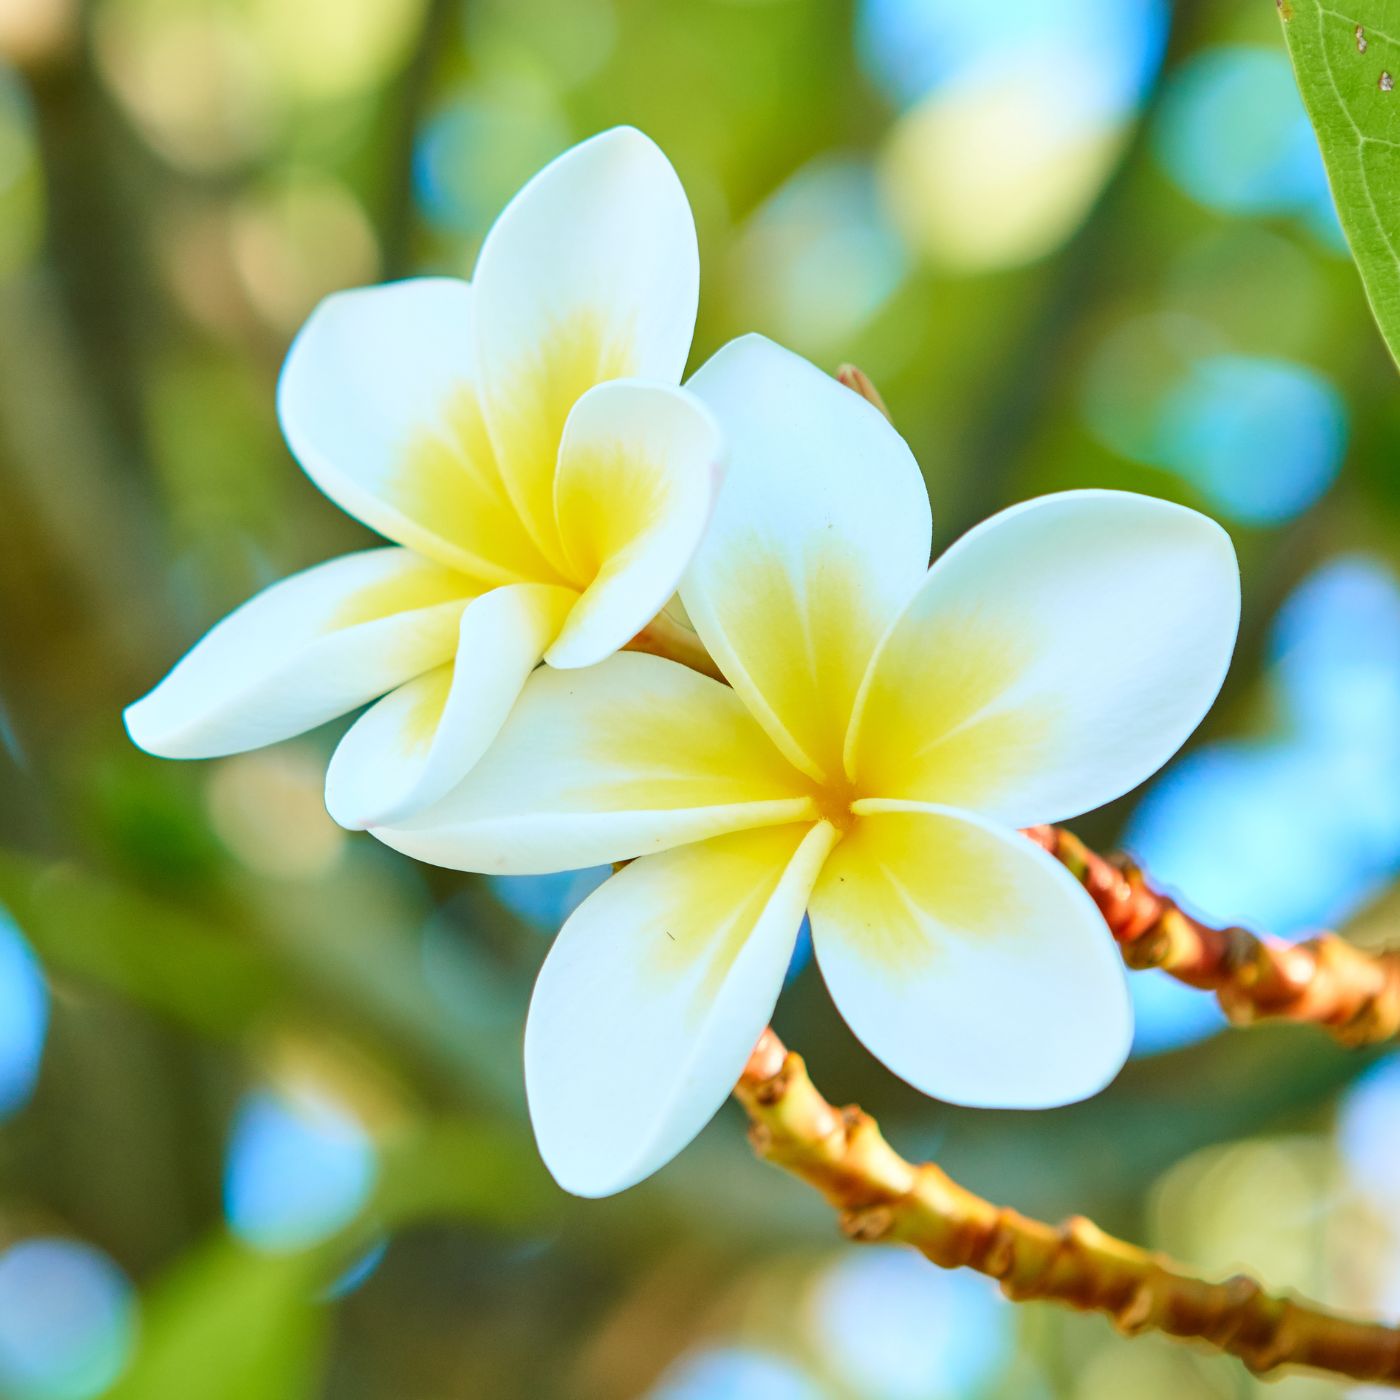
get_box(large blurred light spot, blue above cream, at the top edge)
[858,0,1166,272]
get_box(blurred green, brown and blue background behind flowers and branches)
[0,0,1400,1400]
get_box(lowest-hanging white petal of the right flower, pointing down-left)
[525,823,834,1196]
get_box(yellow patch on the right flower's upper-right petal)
[851,613,1057,809]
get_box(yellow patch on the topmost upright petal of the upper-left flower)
[490,308,637,581]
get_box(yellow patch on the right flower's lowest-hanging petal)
[643,823,812,1025]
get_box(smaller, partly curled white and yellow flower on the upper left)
[126,127,721,826]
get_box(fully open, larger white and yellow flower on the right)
[377,336,1239,1196]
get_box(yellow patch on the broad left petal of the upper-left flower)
[388,384,561,584]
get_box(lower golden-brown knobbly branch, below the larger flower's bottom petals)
[734,1030,1400,1386]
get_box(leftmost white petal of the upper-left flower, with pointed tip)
[126,549,476,759]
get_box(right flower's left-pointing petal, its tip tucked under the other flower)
[374,652,816,875]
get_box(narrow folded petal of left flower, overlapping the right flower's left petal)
[326,584,578,827]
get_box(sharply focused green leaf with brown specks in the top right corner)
[1278,0,1400,363]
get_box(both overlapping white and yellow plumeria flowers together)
[127,129,1239,1196]
